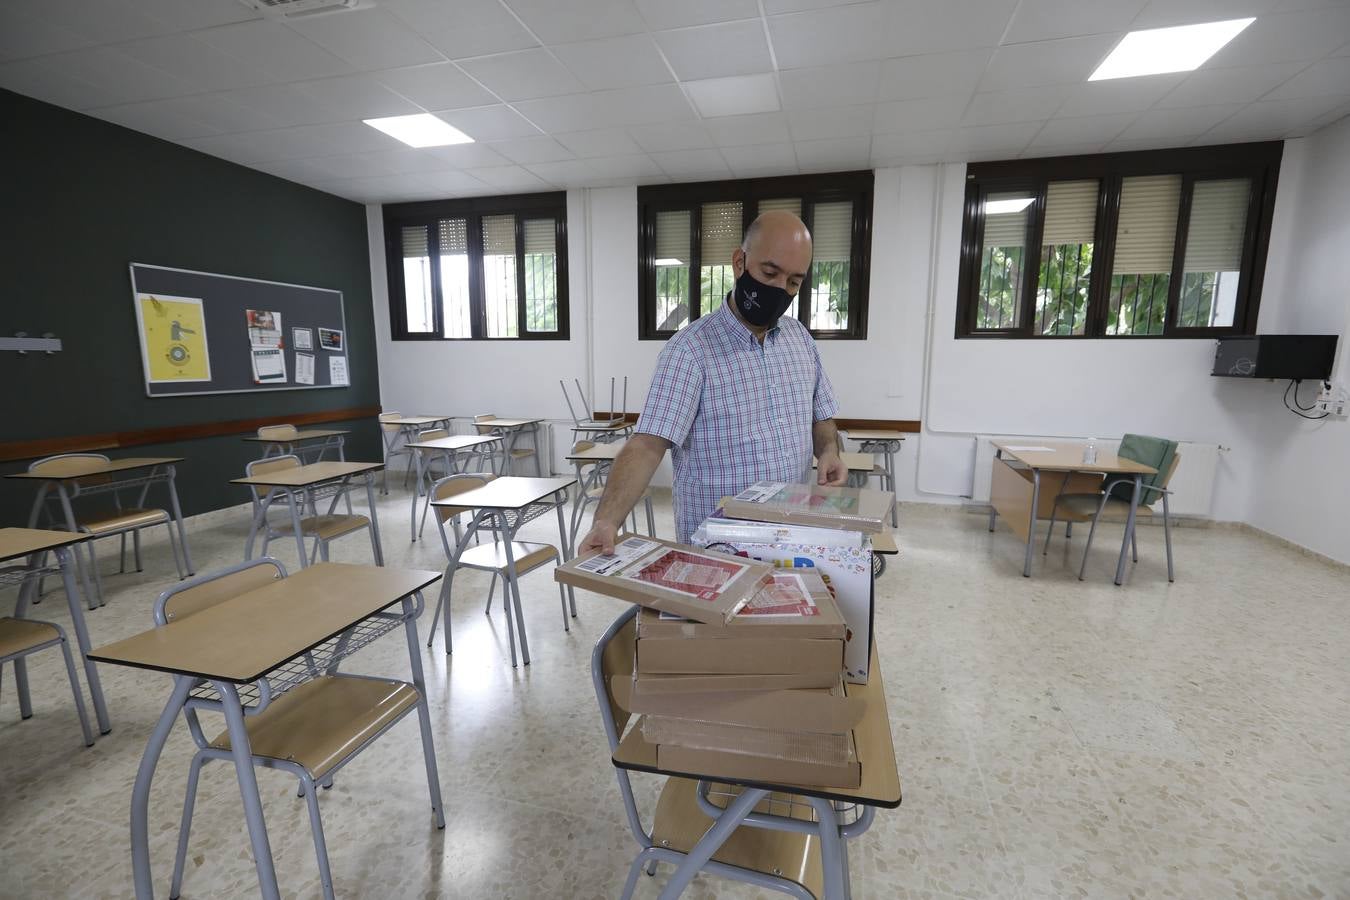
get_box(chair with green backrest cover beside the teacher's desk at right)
[1042,434,1181,582]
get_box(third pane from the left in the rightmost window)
[1106,175,1181,335]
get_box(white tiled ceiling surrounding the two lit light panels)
[0,0,1350,202]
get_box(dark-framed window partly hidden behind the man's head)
[637,171,872,340]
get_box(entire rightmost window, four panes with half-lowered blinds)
[956,143,1281,337]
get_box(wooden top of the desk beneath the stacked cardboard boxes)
[614,644,900,810]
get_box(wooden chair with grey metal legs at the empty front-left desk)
[154,557,446,900]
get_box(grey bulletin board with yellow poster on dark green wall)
[131,263,351,397]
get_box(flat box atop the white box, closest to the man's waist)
[724,482,895,533]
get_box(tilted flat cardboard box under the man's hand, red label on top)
[554,534,772,623]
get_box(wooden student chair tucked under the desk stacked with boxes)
[591,606,875,900]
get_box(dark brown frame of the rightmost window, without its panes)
[956,140,1284,340]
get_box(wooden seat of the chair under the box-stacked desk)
[652,779,824,897]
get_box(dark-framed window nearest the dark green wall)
[385,193,568,340]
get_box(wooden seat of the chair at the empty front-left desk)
[211,675,417,780]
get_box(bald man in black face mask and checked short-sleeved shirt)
[581,210,848,553]
